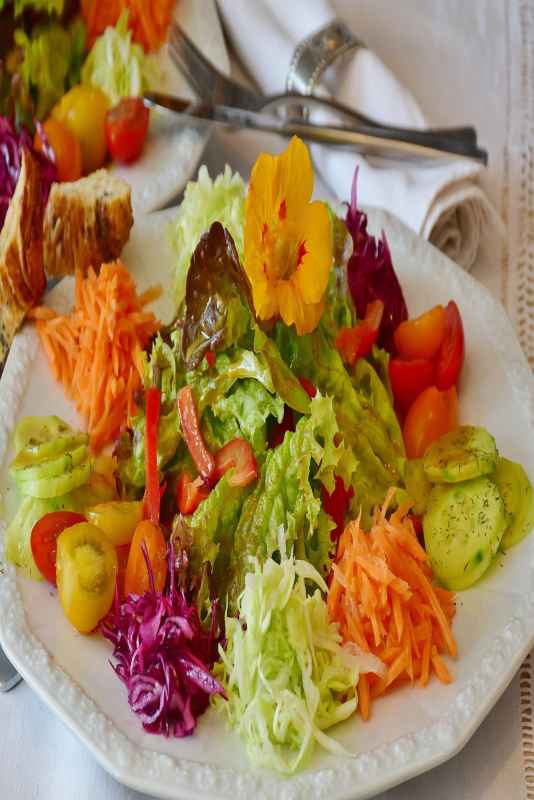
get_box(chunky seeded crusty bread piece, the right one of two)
[43,169,133,278]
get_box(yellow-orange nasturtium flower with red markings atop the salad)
[244,136,333,335]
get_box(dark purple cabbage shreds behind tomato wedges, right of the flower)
[345,168,408,354]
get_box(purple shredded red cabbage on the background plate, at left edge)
[0,116,57,230]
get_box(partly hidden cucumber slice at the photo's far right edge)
[493,458,534,549]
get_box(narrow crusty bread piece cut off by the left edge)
[0,150,46,363]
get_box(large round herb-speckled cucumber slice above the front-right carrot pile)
[423,477,507,591]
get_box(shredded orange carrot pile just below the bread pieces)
[30,261,161,452]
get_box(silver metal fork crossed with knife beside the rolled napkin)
[169,20,477,147]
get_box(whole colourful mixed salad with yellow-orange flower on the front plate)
[5,138,534,774]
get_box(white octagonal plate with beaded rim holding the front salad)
[0,211,534,800]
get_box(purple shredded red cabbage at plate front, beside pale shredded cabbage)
[100,547,225,738]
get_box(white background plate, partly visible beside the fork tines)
[113,0,230,215]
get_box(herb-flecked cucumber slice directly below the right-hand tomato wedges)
[423,425,499,483]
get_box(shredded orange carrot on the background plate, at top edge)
[82,0,175,52]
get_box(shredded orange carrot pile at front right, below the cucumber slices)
[328,489,457,719]
